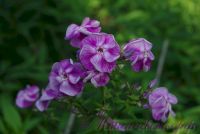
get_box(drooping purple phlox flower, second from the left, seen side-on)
[35,86,64,112]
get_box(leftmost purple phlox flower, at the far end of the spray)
[16,85,39,108]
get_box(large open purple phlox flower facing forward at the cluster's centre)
[79,34,120,73]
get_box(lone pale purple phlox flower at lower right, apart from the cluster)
[148,87,178,122]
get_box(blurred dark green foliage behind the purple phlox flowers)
[0,0,200,134]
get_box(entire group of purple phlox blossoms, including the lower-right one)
[16,17,177,121]
